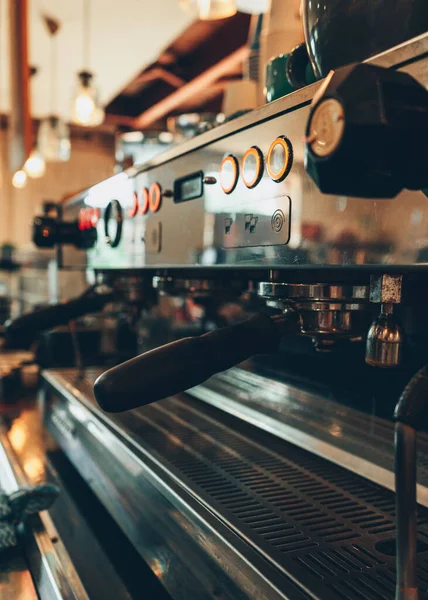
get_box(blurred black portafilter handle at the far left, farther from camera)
[5,288,113,348]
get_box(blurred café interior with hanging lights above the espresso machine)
[0,0,292,251]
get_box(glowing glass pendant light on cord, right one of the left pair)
[73,0,105,127]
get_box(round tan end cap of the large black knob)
[306,98,345,157]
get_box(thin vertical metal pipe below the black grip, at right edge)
[395,422,419,600]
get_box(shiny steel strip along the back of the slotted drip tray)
[189,368,428,506]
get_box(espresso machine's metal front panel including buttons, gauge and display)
[58,37,428,269]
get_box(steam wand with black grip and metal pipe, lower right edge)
[394,366,428,600]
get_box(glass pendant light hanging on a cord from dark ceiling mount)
[37,16,71,162]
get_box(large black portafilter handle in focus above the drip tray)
[94,311,299,412]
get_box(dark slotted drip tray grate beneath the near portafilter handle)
[114,396,428,600]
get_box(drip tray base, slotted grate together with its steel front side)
[41,371,427,600]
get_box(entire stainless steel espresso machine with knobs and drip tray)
[24,34,428,600]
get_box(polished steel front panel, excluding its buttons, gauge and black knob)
[58,35,428,271]
